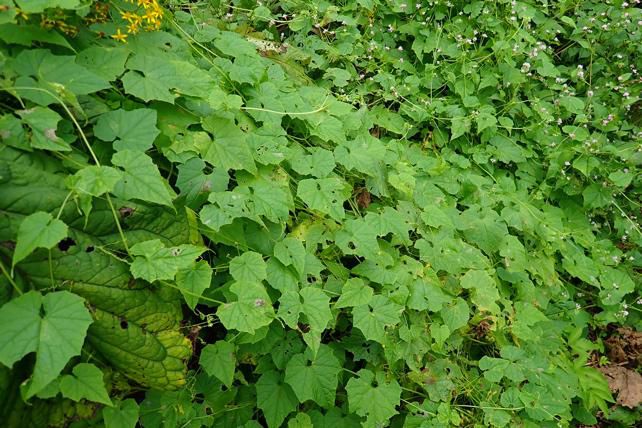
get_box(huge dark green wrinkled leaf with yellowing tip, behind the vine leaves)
[0,148,197,389]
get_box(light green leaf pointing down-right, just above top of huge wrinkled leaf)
[112,150,174,207]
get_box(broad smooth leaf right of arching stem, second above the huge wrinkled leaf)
[94,108,160,152]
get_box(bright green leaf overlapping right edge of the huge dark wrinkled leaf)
[130,239,206,282]
